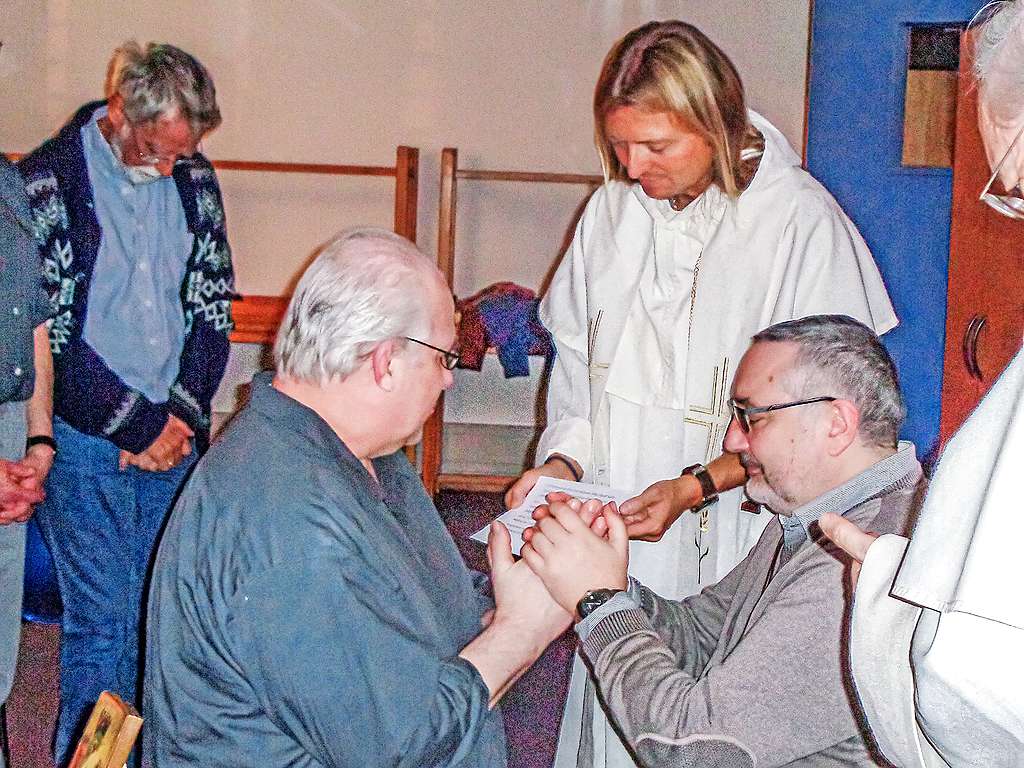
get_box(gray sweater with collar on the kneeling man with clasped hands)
[582,449,926,768]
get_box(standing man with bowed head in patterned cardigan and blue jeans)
[19,42,232,763]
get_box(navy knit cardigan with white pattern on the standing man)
[18,101,233,453]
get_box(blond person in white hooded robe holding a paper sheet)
[506,22,897,768]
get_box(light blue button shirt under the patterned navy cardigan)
[82,105,193,402]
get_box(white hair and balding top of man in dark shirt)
[273,227,441,384]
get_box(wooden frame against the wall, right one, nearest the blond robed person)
[421,146,604,496]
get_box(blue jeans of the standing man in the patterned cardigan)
[36,418,196,765]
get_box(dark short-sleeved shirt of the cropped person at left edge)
[0,154,49,402]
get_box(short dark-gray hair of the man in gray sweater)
[753,314,906,447]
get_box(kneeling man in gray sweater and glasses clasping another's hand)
[523,315,925,768]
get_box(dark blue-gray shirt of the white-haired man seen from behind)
[142,376,506,768]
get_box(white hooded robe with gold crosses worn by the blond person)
[537,113,897,768]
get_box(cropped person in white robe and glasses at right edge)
[821,0,1024,768]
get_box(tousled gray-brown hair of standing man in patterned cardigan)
[105,41,220,139]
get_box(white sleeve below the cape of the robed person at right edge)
[850,536,1024,768]
